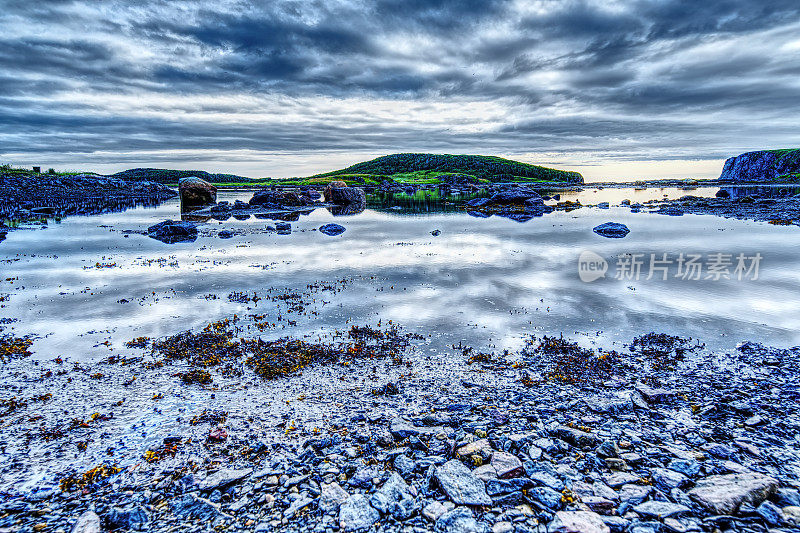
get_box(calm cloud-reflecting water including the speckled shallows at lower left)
[0,190,800,492]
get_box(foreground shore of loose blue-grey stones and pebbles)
[0,318,800,533]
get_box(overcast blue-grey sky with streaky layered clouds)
[0,0,800,179]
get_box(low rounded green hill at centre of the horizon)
[308,154,583,183]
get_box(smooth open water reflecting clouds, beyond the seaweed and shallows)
[0,185,800,360]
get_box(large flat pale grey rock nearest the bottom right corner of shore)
[688,472,778,514]
